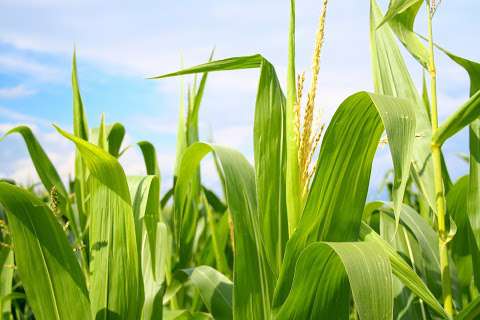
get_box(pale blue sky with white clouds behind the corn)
[0,0,480,196]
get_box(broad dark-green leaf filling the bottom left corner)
[0,182,91,320]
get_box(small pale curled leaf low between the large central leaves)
[182,266,233,320]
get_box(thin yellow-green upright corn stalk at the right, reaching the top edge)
[426,0,453,317]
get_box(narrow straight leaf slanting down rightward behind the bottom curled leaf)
[359,222,448,319]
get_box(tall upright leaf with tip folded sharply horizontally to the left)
[155,54,288,274]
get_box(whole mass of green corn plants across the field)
[0,0,480,320]
